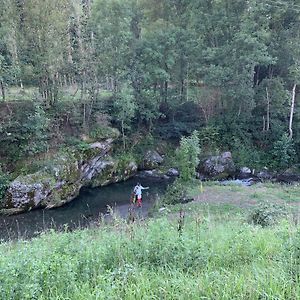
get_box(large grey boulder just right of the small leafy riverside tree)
[199,152,236,180]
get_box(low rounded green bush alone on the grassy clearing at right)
[249,202,287,227]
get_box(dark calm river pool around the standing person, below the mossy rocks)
[0,178,169,241]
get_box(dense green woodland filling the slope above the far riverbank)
[0,0,300,176]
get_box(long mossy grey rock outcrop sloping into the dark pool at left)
[2,139,137,212]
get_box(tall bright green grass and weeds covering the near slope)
[0,184,300,300]
